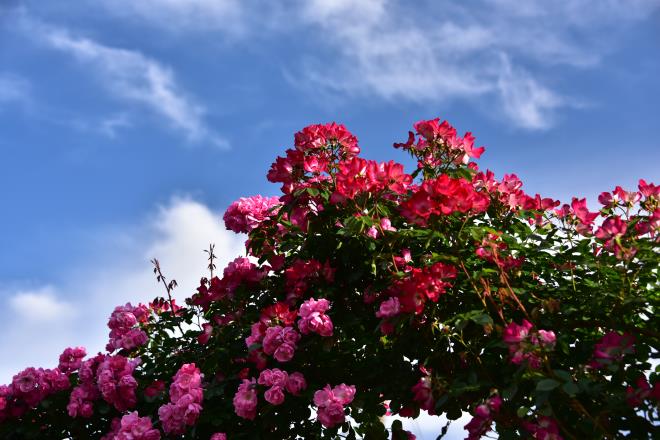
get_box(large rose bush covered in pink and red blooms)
[0,119,660,440]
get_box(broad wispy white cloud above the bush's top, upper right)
[296,0,659,129]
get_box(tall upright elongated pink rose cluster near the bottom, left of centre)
[158,364,204,435]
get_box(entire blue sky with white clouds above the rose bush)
[0,0,660,436]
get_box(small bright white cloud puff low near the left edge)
[9,286,76,323]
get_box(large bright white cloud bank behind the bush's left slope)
[0,199,245,384]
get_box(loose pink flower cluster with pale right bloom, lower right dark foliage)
[502,319,556,368]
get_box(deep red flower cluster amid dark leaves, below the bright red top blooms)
[390,262,456,314]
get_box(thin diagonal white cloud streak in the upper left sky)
[41,26,227,147]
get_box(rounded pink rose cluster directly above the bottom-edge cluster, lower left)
[96,355,140,411]
